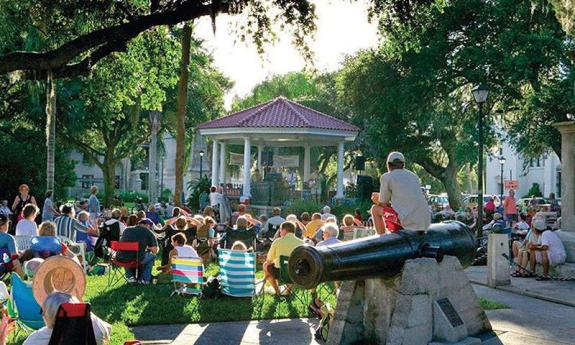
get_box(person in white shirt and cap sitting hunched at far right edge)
[529,226,567,280]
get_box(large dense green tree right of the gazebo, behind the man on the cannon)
[340,0,571,208]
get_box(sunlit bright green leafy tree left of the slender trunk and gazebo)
[59,28,179,205]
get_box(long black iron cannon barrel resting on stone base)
[289,221,476,289]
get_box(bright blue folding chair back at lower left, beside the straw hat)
[8,273,44,333]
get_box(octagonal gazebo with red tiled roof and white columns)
[197,97,359,198]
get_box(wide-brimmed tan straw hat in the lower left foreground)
[32,255,86,305]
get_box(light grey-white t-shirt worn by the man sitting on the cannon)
[379,169,431,231]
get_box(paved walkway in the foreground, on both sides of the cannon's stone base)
[133,267,575,345]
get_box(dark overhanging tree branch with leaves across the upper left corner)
[0,0,315,79]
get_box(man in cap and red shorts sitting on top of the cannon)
[371,152,431,234]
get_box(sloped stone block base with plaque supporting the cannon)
[327,256,491,345]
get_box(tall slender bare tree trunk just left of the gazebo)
[174,24,192,206]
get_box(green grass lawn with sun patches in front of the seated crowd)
[8,262,508,345]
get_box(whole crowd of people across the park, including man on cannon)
[0,152,566,344]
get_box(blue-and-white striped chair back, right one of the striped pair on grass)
[218,249,256,297]
